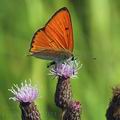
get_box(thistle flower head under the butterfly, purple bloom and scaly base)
[50,59,79,110]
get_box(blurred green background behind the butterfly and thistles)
[0,0,120,120]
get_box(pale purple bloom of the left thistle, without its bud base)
[9,81,38,103]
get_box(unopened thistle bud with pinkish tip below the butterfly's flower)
[63,101,81,120]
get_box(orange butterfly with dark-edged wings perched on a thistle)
[29,7,73,63]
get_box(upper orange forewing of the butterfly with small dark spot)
[45,8,73,51]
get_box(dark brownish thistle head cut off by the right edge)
[106,87,120,120]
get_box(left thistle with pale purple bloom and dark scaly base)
[9,81,40,120]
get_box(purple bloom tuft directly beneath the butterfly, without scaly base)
[50,59,81,79]
